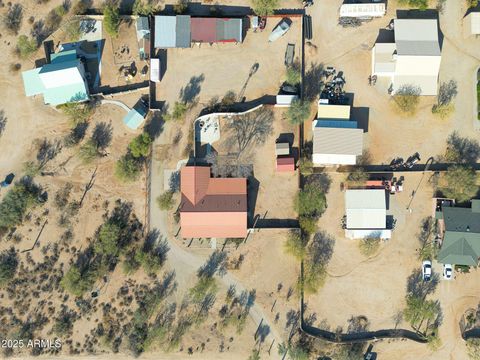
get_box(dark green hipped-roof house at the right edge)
[438,200,480,266]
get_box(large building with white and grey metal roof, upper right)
[372,19,442,95]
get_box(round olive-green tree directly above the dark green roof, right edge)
[439,165,479,202]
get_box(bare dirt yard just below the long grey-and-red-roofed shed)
[156,17,301,104]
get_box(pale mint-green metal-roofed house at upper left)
[22,50,89,106]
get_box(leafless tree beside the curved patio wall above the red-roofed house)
[227,108,273,158]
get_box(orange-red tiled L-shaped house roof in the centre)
[180,166,247,238]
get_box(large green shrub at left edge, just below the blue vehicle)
[0,179,41,229]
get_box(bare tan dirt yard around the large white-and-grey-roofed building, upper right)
[306,0,480,163]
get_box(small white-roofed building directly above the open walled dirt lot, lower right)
[345,189,391,239]
